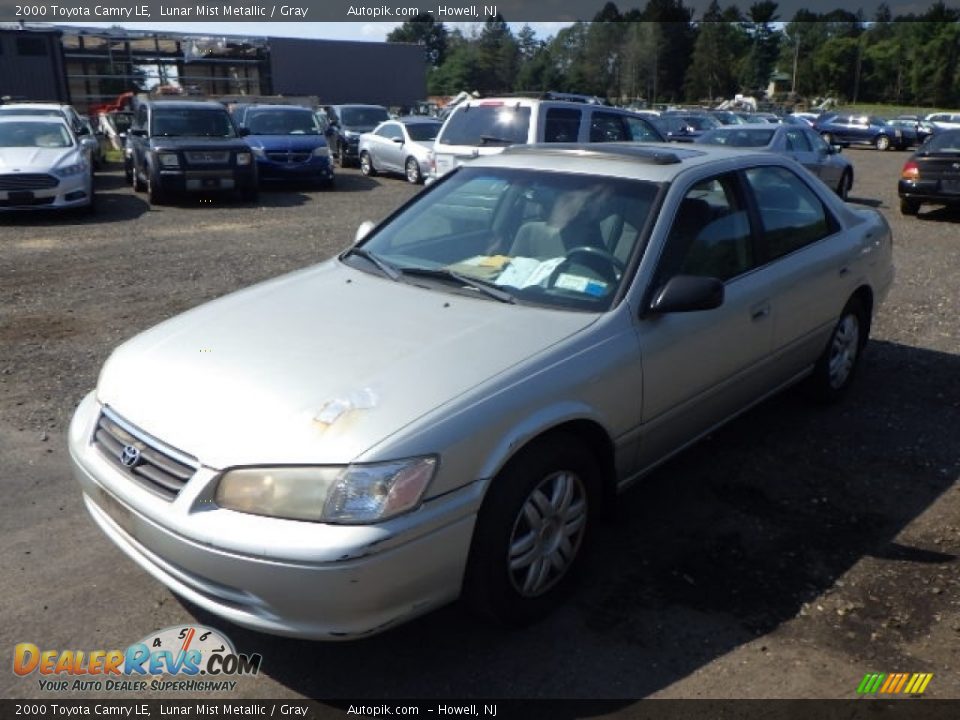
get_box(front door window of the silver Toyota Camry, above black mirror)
[657,174,756,285]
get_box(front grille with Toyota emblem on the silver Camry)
[93,408,200,500]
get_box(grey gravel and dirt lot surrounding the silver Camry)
[0,149,960,707]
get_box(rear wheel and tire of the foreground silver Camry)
[810,297,870,403]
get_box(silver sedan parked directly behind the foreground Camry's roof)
[697,123,853,200]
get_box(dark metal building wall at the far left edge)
[0,30,70,102]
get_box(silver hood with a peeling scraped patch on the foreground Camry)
[97,260,596,468]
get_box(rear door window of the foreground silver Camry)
[746,167,836,260]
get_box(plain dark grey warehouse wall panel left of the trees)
[269,38,427,105]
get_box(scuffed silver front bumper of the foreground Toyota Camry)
[69,393,483,640]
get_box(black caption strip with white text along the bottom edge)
[0,698,960,720]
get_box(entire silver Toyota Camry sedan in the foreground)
[69,143,893,640]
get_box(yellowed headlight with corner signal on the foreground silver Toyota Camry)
[216,457,437,525]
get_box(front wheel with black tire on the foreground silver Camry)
[464,435,600,626]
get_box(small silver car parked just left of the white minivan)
[359,115,443,184]
